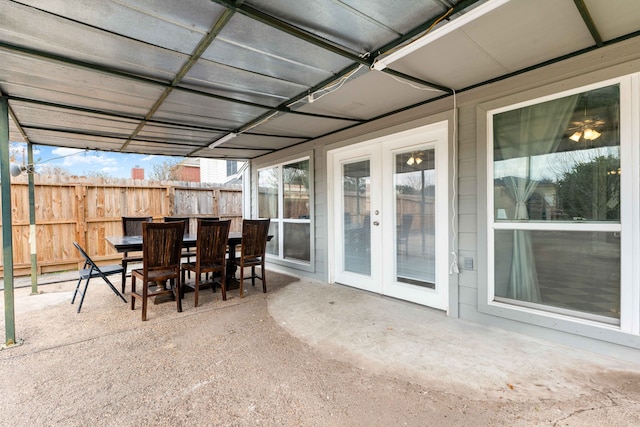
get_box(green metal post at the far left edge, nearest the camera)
[0,97,19,348]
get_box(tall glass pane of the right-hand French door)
[393,150,436,289]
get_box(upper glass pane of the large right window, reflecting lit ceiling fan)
[494,85,622,221]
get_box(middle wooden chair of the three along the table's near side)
[182,219,231,307]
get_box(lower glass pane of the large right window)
[495,230,620,319]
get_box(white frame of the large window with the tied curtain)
[476,74,640,348]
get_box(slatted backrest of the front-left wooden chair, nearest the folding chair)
[142,221,184,270]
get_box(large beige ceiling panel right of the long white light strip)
[390,0,594,89]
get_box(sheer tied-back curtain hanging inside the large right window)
[494,95,579,302]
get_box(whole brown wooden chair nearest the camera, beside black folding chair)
[131,222,184,321]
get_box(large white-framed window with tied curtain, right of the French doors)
[488,83,624,325]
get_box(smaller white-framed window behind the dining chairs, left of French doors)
[258,158,312,264]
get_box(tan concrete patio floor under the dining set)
[0,271,640,426]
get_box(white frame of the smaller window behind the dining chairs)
[253,153,315,272]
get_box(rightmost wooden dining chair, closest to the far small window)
[238,219,270,298]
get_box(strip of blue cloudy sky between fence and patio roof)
[10,142,182,178]
